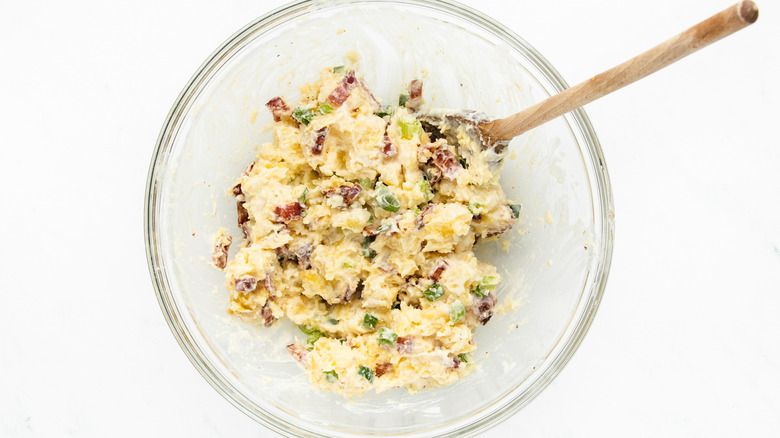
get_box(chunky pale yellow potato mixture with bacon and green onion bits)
[214,66,519,397]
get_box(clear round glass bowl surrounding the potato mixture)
[145,0,614,437]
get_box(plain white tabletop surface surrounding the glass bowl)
[0,0,780,437]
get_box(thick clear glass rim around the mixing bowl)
[144,0,614,437]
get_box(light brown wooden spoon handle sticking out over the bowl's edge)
[480,0,758,140]
